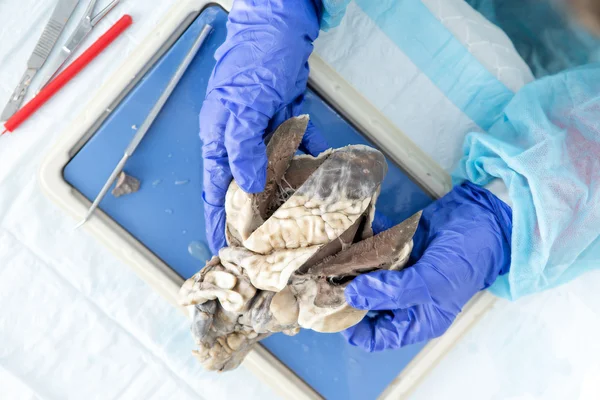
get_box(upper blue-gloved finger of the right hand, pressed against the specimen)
[345,268,432,310]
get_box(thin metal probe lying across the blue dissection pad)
[75,24,212,229]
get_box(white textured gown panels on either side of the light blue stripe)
[315,0,533,172]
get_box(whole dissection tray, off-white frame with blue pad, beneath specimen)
[40,0,493,399]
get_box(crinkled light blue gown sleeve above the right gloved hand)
[457,64,600,299]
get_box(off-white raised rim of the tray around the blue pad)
[39,0,495,400]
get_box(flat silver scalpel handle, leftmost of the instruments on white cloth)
[0,0,79,121]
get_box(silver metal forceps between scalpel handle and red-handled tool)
[38,0,120,91]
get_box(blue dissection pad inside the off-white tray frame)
[64,6,431,400]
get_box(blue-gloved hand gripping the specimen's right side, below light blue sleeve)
[343,182,512,352]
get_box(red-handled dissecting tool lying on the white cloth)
[2,14,133,135]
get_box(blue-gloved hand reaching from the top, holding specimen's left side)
[200,0,329,253]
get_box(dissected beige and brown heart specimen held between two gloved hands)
[180,115,421,371]
